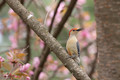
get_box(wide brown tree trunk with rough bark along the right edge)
[94,0,120,80]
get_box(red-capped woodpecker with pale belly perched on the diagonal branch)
[66,28,82,65]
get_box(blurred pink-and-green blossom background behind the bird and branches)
[0,0,97,80]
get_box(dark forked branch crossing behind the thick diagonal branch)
[34,0,77,80]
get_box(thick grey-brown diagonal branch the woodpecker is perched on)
[5,0,90,80]
